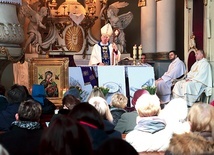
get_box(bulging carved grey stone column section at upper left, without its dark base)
[0,0,24,62]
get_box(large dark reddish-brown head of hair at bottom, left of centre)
[39,116,93,155]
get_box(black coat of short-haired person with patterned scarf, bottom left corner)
[0,123,42,155]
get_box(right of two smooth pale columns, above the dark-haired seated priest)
[157,0,176,52]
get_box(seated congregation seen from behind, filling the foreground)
[0,77,214,155]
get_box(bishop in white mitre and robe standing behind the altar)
[89,24,121,66]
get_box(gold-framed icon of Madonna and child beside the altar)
[29,58,69,106]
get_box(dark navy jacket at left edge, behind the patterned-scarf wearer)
[0,102,20,131]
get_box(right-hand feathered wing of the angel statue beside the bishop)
[118,11,133,29]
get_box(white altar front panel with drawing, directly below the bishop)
[97,66,126,104]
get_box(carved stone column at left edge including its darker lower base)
[0,0,24,89]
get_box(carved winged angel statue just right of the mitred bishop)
[107,1,133,53]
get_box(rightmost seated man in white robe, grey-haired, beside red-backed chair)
[173,50,212,106]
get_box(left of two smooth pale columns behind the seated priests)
[141,0,156,53]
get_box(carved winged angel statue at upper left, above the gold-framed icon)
[19,2,48,53]
